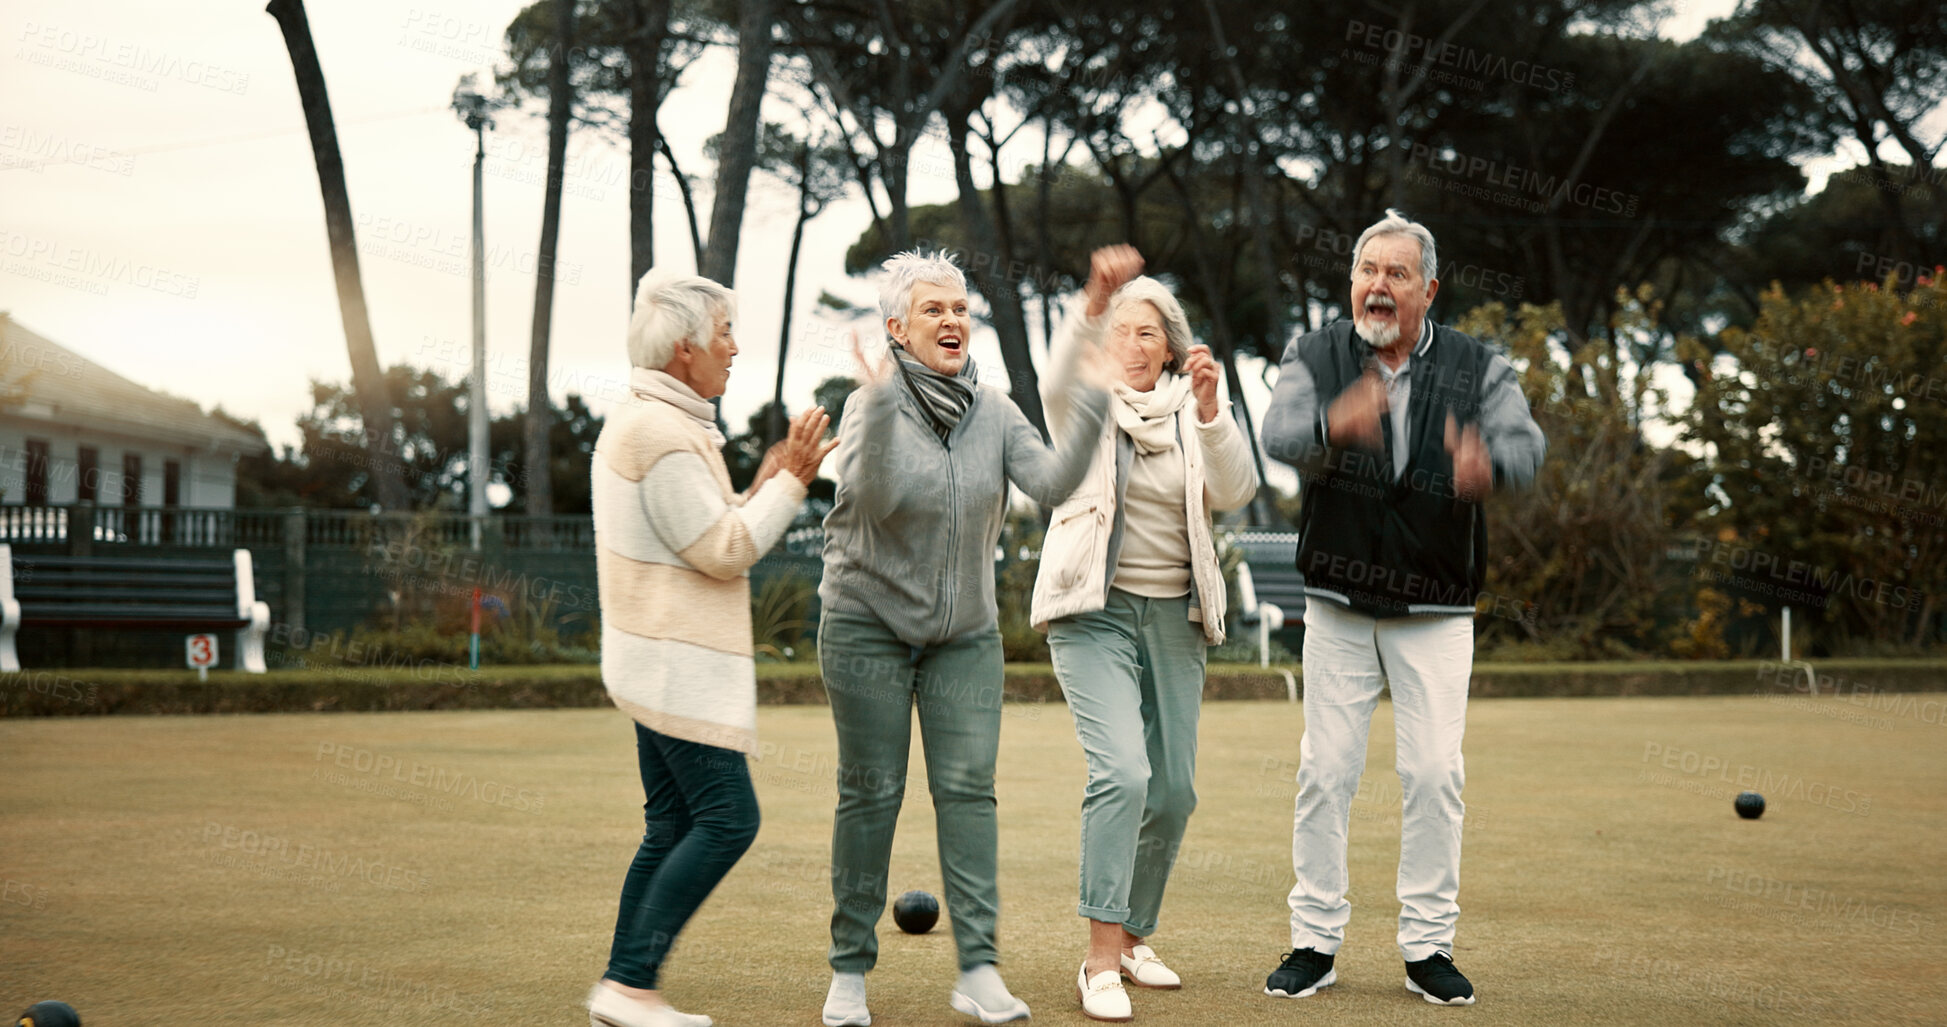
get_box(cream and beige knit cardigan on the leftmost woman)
[592,370,804,752]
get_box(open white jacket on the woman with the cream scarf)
[1028,300,1258,645]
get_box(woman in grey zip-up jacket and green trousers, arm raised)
[818,251,1108,1027]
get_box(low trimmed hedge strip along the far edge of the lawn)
[0,659,1947,717]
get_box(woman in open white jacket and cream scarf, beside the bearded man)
[1030,246,1258,1021]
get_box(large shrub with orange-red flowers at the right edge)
[1684,275,1947,655]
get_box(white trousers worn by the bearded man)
[1289,598,1474,963]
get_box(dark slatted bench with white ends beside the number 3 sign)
[0,544,271,674]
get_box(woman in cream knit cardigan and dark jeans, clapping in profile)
[588,271,837,1027]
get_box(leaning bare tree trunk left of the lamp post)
[265,0,411,511]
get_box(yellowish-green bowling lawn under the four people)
[0,694,1947,1027]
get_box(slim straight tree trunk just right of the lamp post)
[522,0,574,516]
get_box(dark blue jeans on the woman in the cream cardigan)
[606,725,757,988]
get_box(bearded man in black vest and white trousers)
[1264,210,1548,1006]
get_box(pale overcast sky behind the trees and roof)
[0,0,1733,489]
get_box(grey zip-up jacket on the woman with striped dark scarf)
[818,364,1108,645]
